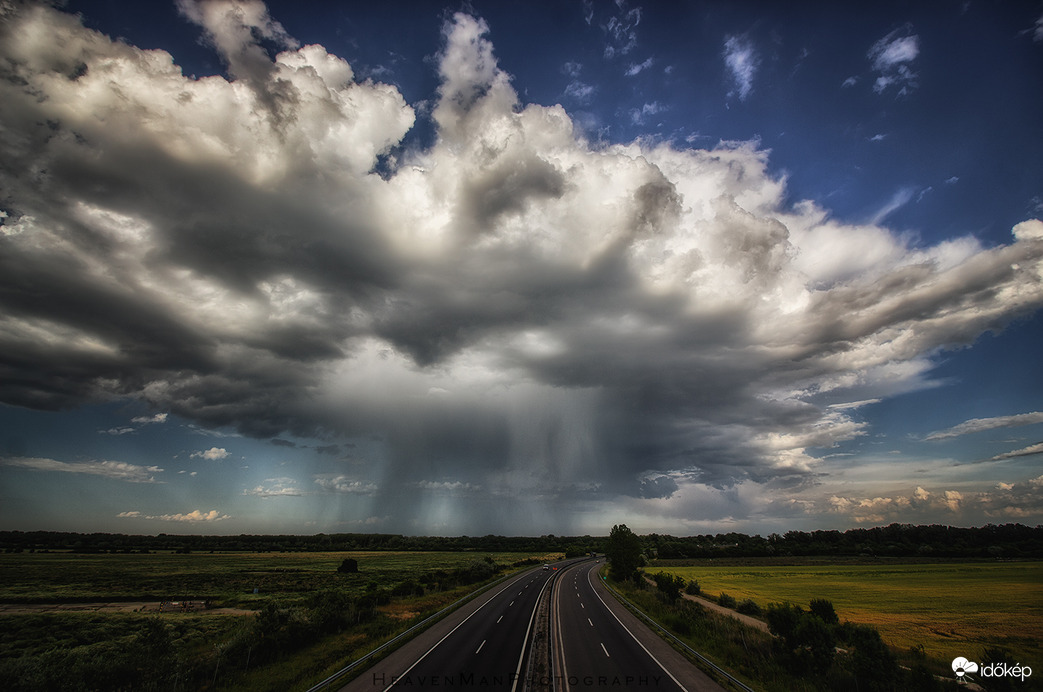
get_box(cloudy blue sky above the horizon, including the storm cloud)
[0,0,1043,535]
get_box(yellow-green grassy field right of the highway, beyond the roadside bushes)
[647,559,1043,670]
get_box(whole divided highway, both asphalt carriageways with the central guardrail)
[341,559,723,692]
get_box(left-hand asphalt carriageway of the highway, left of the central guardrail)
[342,568,555,692]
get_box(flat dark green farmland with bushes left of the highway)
[0,551,560,690]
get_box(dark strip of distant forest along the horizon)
[0,524,1043,559]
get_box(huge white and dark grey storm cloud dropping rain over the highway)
[0,0,1043,525]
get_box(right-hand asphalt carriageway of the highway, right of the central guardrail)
[551,563,723,692]
